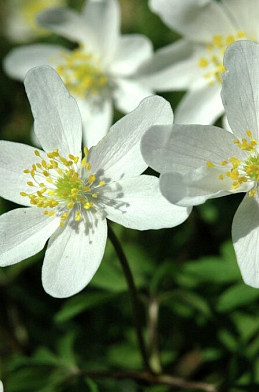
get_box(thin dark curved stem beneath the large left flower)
[108,225,153,373]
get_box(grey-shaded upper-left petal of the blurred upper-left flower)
[37,7,96,51]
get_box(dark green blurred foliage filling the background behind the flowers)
[0,0,259,392]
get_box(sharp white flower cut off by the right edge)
[142,41,259,287]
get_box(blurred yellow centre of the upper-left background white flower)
[56,48,109,100]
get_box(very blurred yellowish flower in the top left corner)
[4,0,66,42]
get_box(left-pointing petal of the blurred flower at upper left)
[3,44,66,81]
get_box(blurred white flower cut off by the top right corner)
[142,0,259,124]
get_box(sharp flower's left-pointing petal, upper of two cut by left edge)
[0,140,47,206]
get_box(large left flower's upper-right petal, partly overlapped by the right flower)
[89,96,173,181]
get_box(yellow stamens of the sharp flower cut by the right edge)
[207,130,259,197]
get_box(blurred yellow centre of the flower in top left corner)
[21,0,65,32]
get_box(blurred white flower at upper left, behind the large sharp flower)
[4,0,152,146]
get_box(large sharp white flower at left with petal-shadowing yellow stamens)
[0,66,190,297]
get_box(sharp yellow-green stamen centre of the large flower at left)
[20,148,105,226]
